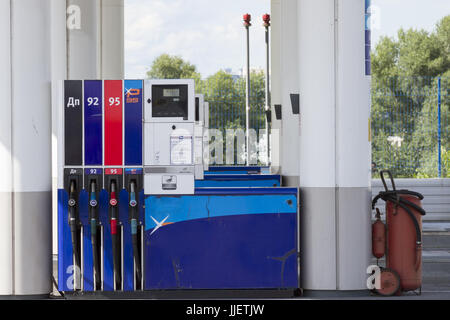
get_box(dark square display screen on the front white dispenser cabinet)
[152,85,188,120]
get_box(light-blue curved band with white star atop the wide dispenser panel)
[145,194,297,231]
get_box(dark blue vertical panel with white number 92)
[84,80,103,165]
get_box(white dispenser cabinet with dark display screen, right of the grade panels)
[144,79,195,194]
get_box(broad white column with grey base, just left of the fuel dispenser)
[9,0,52,295]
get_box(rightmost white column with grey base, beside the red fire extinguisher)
[336,0,372,290]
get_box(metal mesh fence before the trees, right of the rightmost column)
[372,77,450,178]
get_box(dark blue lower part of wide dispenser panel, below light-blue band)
[145,213,298,290]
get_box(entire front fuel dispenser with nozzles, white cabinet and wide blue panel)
[58,79,299,296]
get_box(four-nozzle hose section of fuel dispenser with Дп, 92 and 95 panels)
[53,80,144,292]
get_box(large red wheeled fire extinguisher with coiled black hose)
[372,171,425,296]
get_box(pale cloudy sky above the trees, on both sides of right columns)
[125,0,450,79]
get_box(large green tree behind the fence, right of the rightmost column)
[372,16,450,177]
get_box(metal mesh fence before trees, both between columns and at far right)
[197,72,450,178]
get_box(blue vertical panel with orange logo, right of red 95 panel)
[124,80,143,166]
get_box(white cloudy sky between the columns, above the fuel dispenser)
[125,0,270,78]
